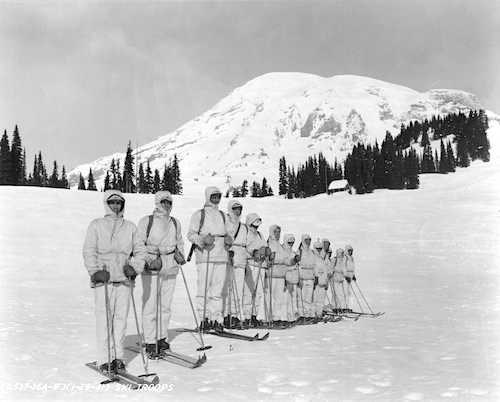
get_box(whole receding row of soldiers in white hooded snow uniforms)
[83,187,356,371]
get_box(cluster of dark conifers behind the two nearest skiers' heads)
[78,141,182,194]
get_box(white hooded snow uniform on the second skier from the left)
[137,191,184,344]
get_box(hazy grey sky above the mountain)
[0,0,500,170]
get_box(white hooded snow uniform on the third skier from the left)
[188,187,231,323]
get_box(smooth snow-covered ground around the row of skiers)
[0,122,500,401]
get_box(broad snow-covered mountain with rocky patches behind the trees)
[69,73,481,193]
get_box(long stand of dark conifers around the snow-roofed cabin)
[279,110,490,198]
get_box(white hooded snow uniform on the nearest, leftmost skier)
[83,190,145,363]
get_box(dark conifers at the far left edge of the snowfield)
[0,124,69,188]
